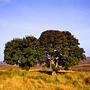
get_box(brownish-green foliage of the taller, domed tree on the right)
[39,30,85,69]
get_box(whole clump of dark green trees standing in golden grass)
[4,30,85,70]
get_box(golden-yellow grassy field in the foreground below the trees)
[0,66,90,90]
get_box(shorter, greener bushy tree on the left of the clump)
[4,36,37,69]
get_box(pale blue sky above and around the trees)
[0,0,90,60]
